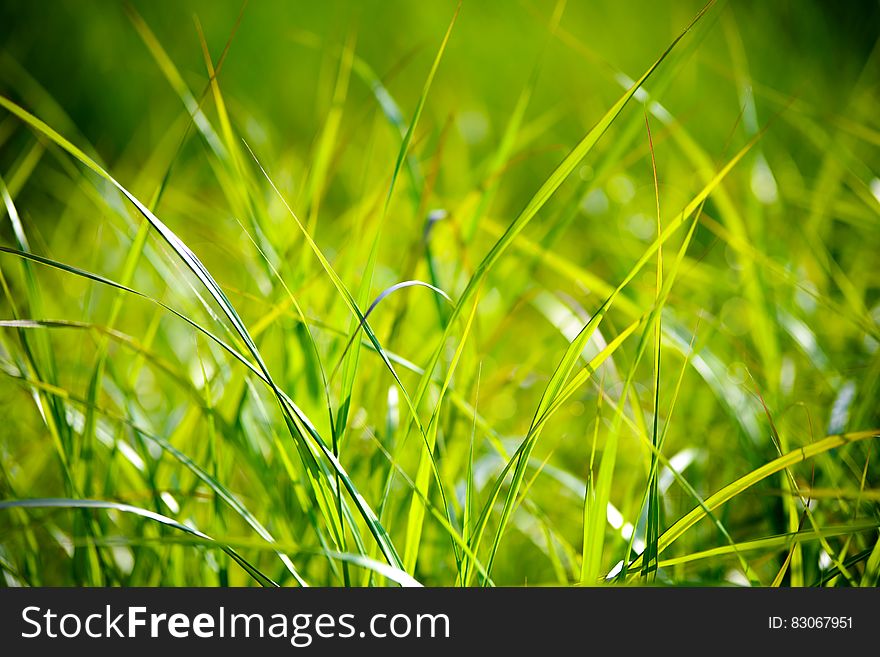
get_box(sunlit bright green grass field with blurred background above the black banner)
[0,0,880,587]
